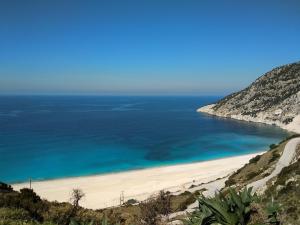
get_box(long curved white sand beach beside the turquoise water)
[13,153,259,209]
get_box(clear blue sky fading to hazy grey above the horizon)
[0,0,300,95]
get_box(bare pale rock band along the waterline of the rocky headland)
[197,104,300,134]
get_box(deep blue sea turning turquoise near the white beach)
[0,96,288,183]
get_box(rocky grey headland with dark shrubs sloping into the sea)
[198,62,300,132]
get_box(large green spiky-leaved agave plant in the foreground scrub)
[184,188,257,225]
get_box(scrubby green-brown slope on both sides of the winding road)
[225,139,300,225]
